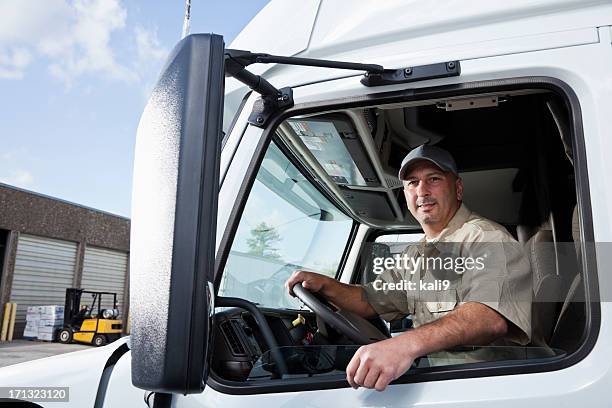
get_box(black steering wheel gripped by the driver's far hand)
[293,283,388,345]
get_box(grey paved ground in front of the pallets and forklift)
[0,340,92,367]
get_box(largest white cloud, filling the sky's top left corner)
[0,0,143,85]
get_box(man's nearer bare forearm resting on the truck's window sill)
[397,302,508,358]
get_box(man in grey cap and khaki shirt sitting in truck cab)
[286,145,532,391]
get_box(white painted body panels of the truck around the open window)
[0,0,612,408]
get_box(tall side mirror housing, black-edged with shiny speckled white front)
[130,34,224,394]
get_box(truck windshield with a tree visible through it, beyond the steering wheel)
[219,143,353,309]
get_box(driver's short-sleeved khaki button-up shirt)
[364,205,532,345]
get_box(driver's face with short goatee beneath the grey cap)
[404,160,463,232]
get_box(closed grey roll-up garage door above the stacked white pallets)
[11,234,77,337]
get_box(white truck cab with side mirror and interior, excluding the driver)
[0,0,612,407]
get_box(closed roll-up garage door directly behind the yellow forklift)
[81,247,128,315]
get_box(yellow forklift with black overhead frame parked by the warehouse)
[57,288,123,347]
